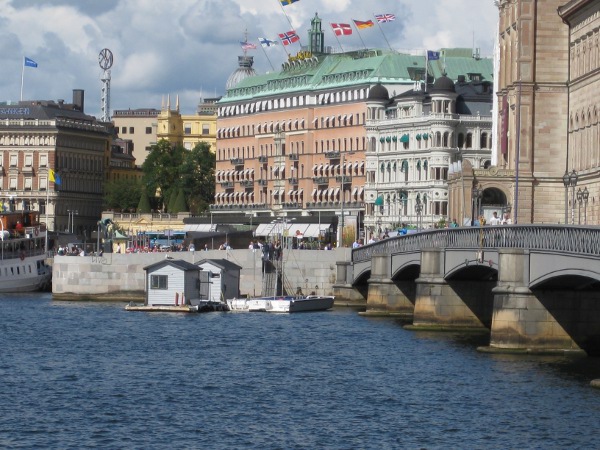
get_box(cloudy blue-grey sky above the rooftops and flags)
[0,0,498,117]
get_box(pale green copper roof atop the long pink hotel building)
[219,49,493,104]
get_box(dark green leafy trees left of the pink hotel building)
[142,140,216,214]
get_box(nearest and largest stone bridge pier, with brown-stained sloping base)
[484,249,581,353]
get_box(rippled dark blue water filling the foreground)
[0,295,600,449]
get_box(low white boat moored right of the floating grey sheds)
[227,295,334,313]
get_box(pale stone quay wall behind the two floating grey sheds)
[52,248,351,302]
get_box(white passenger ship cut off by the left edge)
[0,211,52,293]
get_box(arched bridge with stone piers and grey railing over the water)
[334,225,600,355]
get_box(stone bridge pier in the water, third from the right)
[366,254,414,316]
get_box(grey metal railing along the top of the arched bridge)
[352,225,600,262]
